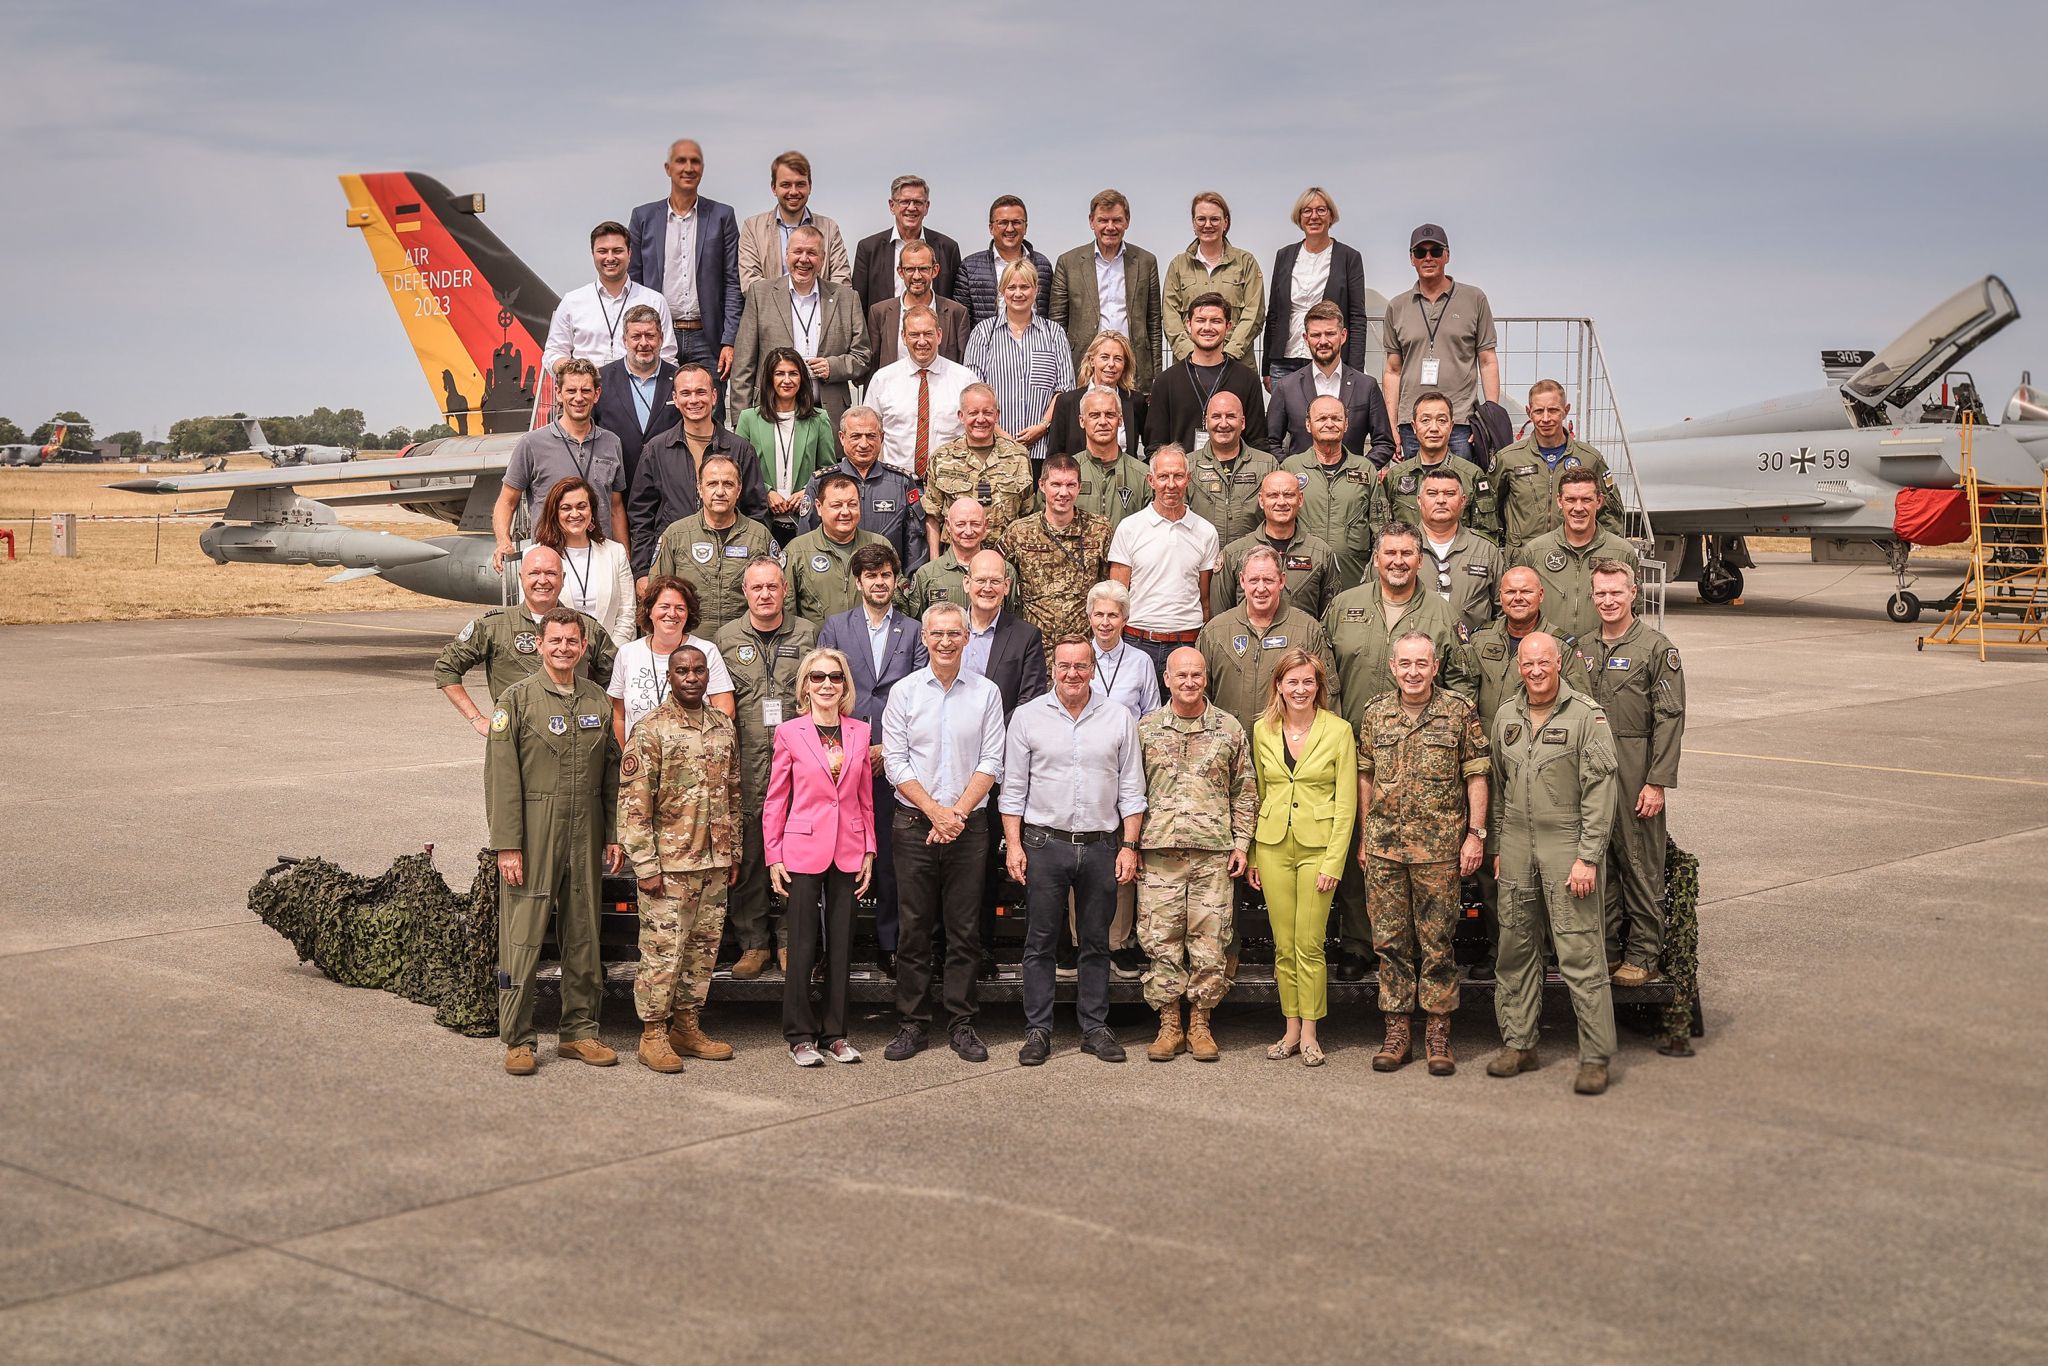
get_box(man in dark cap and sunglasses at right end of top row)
[1380,223,1501,459]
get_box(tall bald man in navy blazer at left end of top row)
[627,137,739,405]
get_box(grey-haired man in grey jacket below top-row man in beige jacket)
[731,225,868,430]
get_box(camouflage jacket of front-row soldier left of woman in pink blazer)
[618,698,741,879]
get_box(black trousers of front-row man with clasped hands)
[889,801,989,1034]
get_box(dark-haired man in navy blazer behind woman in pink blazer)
[817,545,930,973]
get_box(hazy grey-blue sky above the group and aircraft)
[0,0,2048,436]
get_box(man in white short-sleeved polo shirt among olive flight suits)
[1110,446,1223,678]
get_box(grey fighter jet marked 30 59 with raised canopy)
[1628,274,2048,621]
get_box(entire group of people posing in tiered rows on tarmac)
[436,139,1683,1092]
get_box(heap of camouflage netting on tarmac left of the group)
[250,850,498,1036]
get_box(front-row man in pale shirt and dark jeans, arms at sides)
[997,635,1145,1067]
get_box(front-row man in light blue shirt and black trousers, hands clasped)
[874,602,1004,1063]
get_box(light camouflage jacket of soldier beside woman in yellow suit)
[1139,702,1260,854]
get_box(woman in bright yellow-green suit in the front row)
[1251,649,1358,1067]
